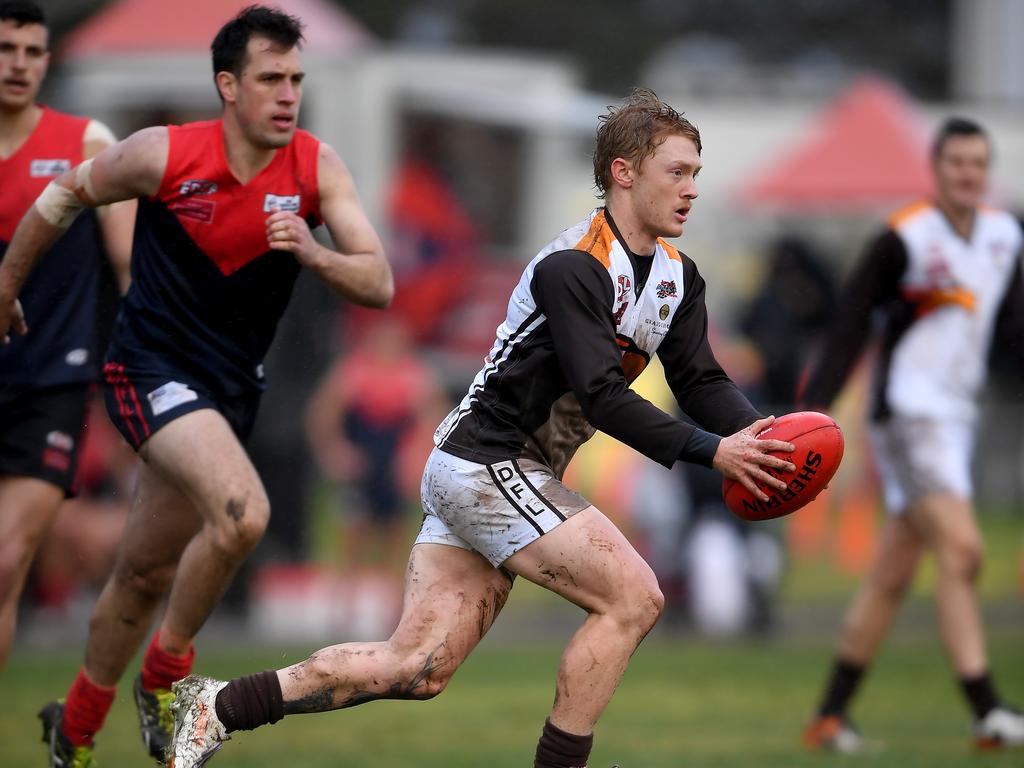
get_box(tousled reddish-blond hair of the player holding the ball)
[594,88,700,198]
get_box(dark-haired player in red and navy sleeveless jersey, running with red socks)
[0,6,392,768]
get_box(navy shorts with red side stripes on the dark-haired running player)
[103,361,259,451]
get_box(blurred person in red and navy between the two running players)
[306,315,443,635]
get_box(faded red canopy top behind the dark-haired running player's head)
[61,0,371,58]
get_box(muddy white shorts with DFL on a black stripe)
[416,447,590,568]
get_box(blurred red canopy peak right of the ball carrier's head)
[738,79,932,211]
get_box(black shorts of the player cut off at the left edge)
[0,382,95,496]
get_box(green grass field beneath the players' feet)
[0,621,1024,768]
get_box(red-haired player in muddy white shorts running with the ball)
[172,91,794,768]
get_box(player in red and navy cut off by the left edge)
[0,0,135,669]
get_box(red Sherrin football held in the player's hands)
[722,411,843,520]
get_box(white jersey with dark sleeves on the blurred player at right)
[805,202,1024,423]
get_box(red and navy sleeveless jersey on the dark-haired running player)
[108,120,322,396]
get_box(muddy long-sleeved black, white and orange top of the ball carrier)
[435,208,759,476]
